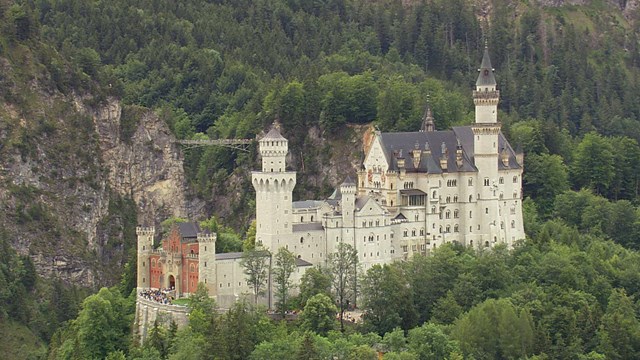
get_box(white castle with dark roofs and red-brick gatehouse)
[138,49,525,324]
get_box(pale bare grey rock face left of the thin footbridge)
[92,100,188,225]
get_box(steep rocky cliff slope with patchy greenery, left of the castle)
[0,39,192,287]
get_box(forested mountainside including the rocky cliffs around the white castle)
[0,0,640,358]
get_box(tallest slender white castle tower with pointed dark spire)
[471,46,500,245]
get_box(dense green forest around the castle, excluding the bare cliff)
[0,0,640,359]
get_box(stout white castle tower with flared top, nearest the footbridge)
[251,125,296,252]
